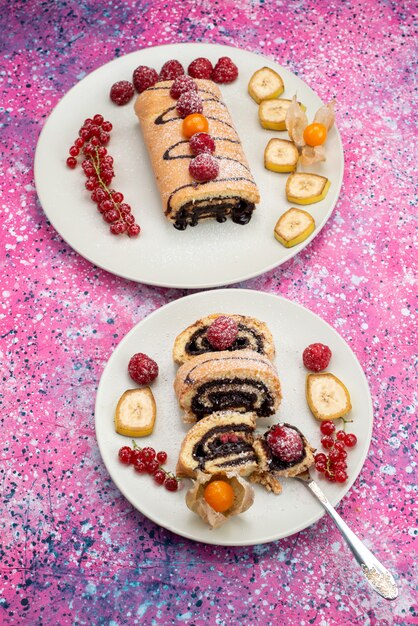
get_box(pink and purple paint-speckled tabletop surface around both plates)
[0,0,418,626]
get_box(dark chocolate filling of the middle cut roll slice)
[191,378,274,420]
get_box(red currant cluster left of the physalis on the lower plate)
[118,441,179,491]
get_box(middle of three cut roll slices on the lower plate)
[174,350,281,422]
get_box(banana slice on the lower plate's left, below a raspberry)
[115,387,157,437]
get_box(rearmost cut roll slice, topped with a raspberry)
[173,313,275,365]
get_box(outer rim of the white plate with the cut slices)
[94,288,374,547]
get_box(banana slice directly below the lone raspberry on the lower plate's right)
[306,372,351,420]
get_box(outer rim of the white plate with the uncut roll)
[34,42,345,290]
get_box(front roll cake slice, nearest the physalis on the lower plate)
[176,411,258,478]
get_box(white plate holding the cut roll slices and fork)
[96,289,373,546]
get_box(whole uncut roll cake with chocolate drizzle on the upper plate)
[135,79,260,230]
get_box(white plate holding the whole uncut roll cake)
[35,44,344,289]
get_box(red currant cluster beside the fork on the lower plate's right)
[315,420,357,483]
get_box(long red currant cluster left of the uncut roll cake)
[67,114,141,237]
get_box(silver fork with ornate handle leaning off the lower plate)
[295,471,398,600]
